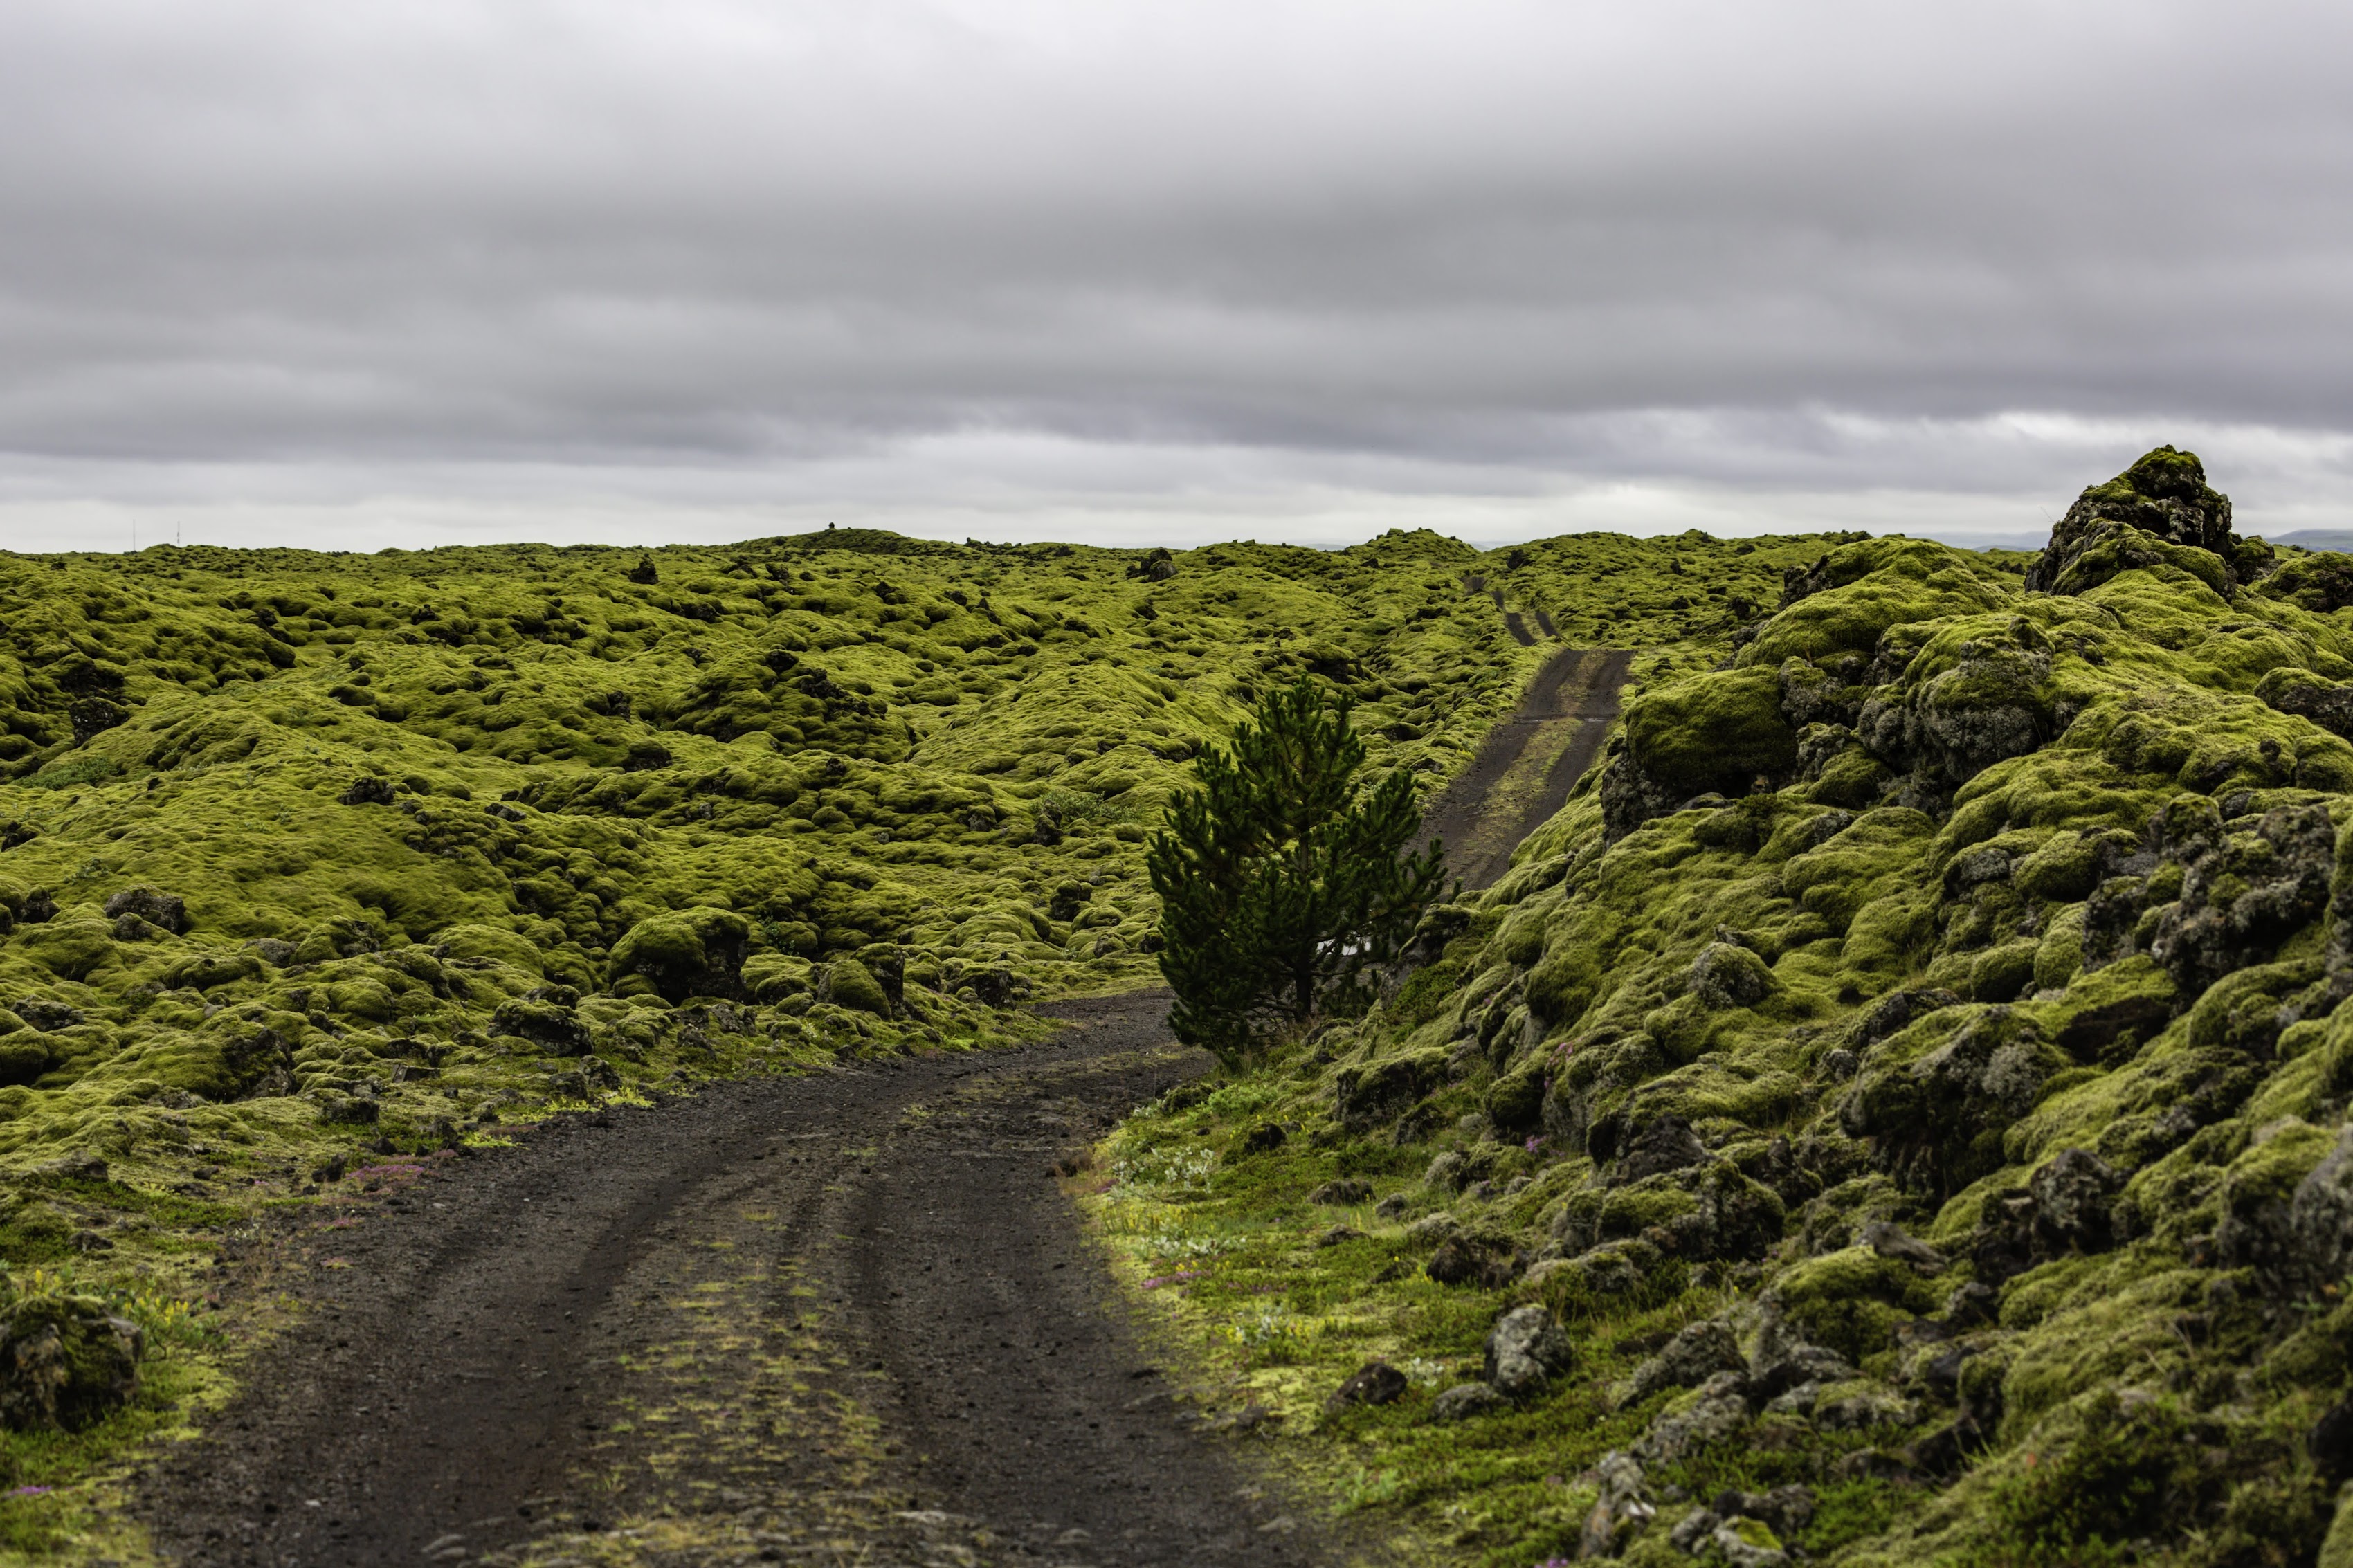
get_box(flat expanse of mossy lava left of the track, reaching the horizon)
[0,516,1837,1554]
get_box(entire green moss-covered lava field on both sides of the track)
[32,450,2353,1568]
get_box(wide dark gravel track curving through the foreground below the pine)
[139,994,1318,1568]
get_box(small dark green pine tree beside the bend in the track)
[1146,680,1445,1066]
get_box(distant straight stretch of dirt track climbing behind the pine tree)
[1424,648,1633,888]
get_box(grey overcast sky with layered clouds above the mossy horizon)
[0,0,2353,549]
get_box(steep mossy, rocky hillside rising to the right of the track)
[1099,454,2353,1568]
